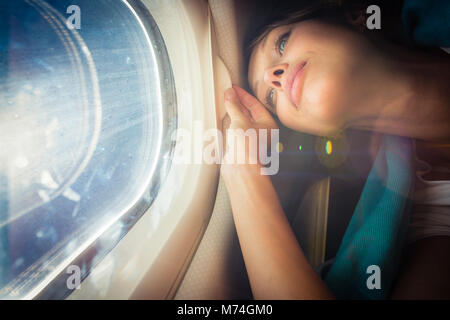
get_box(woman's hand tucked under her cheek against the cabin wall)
[225,85,278,168]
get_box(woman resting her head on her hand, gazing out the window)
[222,0,450,299]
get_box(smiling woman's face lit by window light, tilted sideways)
[248,20,372,135]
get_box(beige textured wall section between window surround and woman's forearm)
[175,180,252,300]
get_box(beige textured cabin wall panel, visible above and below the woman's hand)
[175,0,252,299]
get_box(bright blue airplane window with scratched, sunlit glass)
[0,0,176,298]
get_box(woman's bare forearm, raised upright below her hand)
[222,165,332,299]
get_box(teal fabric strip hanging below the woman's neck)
[325,135,413,299]
